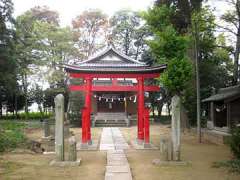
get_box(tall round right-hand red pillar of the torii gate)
[138,77,144,142]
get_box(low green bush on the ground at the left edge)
[0,121,26,152]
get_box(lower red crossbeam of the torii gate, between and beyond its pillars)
[69,85,160,92]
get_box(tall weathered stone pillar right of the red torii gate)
[171,95,181,161]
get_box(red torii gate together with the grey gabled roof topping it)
[64,47,166,144]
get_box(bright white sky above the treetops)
[12,0,153,25]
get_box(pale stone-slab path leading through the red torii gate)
[100,128,132,180]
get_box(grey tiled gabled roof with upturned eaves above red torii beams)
[64,47,166,73]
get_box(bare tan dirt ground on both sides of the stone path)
[0,124,240,180]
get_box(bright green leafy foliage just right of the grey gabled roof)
[143,5,192,95]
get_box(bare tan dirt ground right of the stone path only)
[122,125,240,180]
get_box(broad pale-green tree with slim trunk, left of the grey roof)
[16,7,76,112]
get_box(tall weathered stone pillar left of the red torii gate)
[54,94,64,161]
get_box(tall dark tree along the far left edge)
[0,0,17,117]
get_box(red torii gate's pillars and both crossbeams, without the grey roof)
[69,73,160,144]
